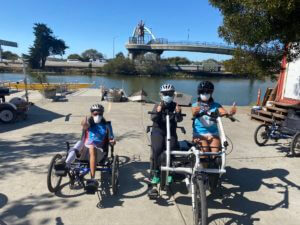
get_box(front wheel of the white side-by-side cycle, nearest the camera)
[192,177,208,225]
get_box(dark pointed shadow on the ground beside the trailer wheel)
[0,105,64,133]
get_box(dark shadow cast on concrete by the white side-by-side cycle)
[207,167,300,225]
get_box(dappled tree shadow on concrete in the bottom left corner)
[0,194,79,224]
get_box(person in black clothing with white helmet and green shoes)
[151,84,182,190]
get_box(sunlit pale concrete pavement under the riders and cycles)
[0,89,300,225]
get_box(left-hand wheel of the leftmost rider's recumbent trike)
[47,154,62,192]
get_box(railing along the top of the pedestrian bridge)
[129,37,234,49]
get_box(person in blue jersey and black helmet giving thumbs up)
[192,81,236,156]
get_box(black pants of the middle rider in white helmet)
[151,130,178,170]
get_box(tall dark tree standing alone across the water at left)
[28,23,68,69]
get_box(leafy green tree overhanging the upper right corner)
[209,0,300,76]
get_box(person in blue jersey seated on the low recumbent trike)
[81,104,115,179]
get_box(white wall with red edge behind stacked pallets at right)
[275,51,300,104]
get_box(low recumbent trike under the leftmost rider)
[47,123,119,195]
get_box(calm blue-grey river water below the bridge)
[0,73,275,106]
